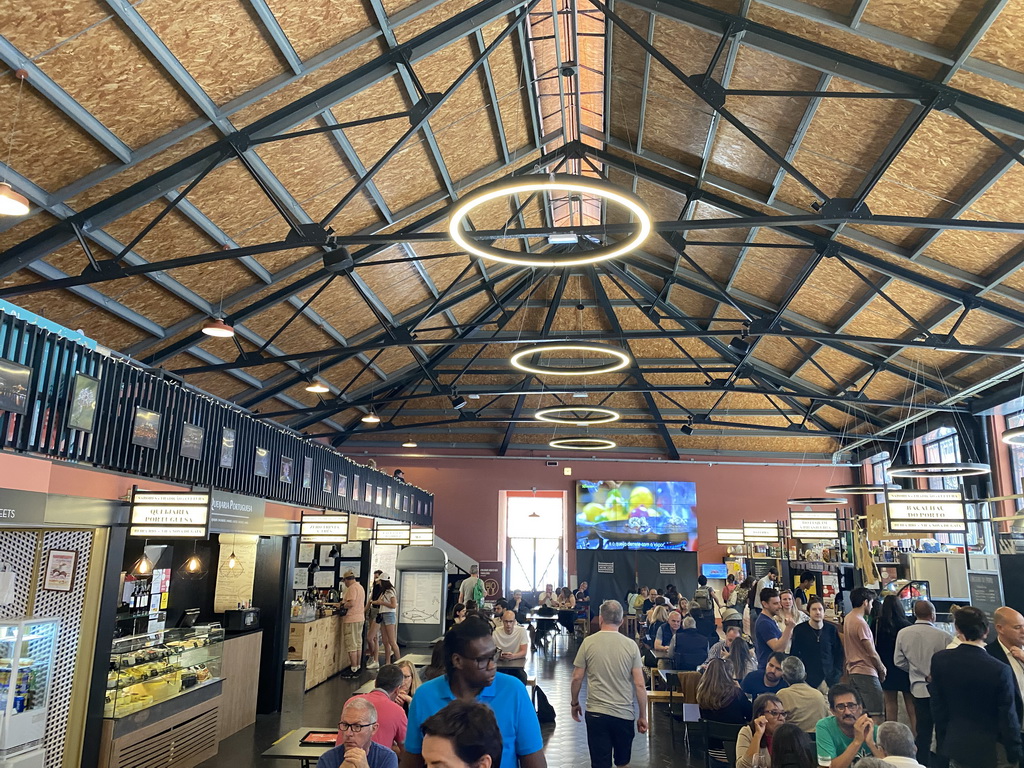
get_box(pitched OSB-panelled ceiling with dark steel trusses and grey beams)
[0,0,1024,459]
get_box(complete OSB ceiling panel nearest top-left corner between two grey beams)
[36,19,200,147]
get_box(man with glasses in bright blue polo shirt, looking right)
[401,616,548,768]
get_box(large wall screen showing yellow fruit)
[577,480,697,552]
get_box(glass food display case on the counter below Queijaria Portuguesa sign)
[103,624,224,719]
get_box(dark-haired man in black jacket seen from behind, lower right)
[929,606,1021,768]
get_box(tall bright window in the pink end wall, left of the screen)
[505,493,565,592]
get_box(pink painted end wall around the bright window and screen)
[385,457,855,573]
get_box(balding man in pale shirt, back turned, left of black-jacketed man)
[893,600,952,765]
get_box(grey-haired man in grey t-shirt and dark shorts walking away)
[571,600,647,768]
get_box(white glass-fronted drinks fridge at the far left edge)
[0,618,59,755]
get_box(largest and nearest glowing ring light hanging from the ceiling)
[449,173,651,266]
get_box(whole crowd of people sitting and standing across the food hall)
[317,572,1024,768]
